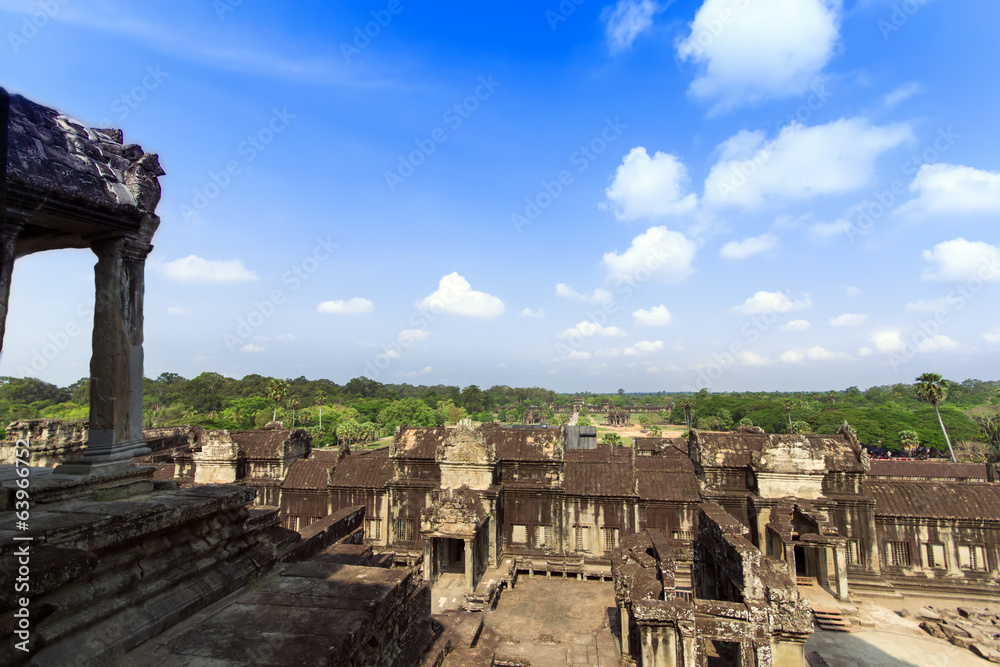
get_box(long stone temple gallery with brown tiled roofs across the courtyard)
[281,424,1000,599]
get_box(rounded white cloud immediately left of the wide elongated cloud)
[604,146,698,220]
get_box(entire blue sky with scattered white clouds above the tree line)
[0,0,1000,392]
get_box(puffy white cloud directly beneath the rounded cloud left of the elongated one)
[602,225,695,283]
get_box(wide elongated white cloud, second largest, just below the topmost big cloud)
[704,118,913,206]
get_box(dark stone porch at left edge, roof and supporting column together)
[0,89,164,474]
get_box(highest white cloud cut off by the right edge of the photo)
[895,162,1000,217]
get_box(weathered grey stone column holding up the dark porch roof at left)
[55,238,152,475]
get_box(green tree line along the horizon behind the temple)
[0,372,1000,460]
